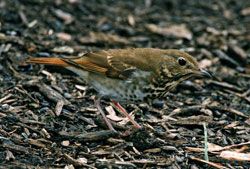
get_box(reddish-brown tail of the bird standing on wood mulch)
[26,57,68,67]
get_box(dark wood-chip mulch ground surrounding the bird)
[0,0,250,169]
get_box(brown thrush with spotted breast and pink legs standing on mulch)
[27,48,210,131]
